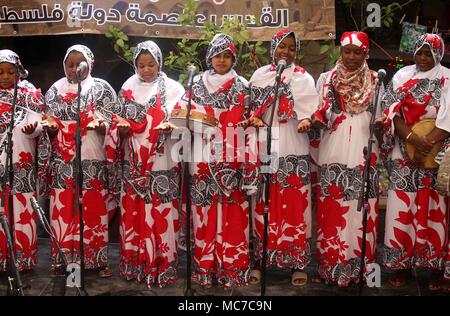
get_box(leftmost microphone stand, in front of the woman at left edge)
[0,62,24,296]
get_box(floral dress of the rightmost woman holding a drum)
[383,64,450,270]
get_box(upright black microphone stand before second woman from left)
[73,69,88,295]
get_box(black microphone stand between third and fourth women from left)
[178,66,194,296]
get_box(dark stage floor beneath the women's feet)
[0,238,445,296]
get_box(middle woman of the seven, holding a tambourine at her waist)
[172,34,257,288]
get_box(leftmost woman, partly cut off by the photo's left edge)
[0,49,44,272]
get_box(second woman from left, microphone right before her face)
[44,45,118,277]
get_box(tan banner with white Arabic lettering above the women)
[0,0,336,40]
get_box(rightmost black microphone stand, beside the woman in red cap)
[357,71,382,295]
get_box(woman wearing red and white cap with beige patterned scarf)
[313,32,383,286]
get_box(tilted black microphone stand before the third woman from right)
[261,71,280,296]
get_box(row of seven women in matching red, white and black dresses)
[0,30,450,290]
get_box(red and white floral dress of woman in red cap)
[315,65,383,286]
